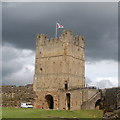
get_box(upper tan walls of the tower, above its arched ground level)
[34,31,85,91]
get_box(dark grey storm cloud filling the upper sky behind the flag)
[2,3,118,60]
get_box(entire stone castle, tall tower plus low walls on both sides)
[0,30,120,111]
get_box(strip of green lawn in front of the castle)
[2,108,103,118]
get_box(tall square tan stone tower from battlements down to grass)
[34,30,85,110]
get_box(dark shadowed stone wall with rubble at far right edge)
[102,87,120,120]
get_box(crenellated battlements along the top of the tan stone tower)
[36,30,84,48]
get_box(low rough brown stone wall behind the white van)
[2,84,35,107]
